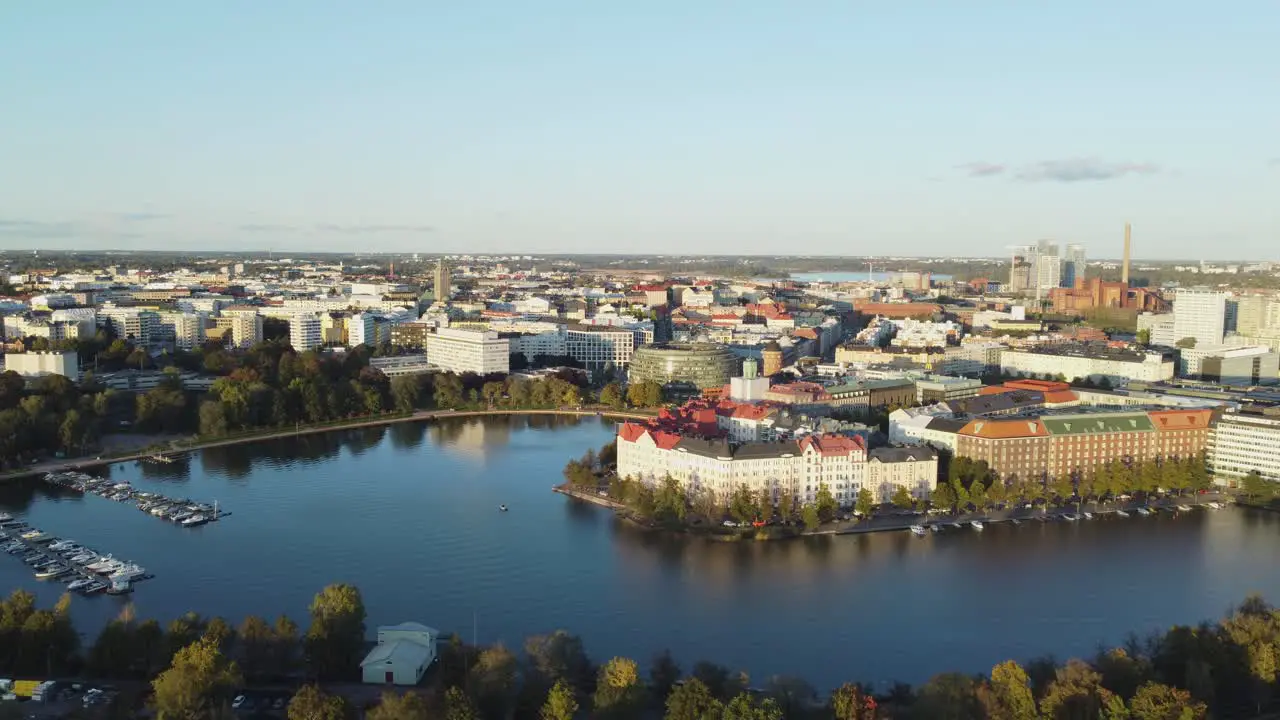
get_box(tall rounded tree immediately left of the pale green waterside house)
[306,584,365,679]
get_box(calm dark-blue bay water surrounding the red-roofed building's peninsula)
[0,419,1280,688]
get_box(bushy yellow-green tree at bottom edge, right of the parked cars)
[151,638,242,720]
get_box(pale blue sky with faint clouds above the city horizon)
[0,0,1280,260]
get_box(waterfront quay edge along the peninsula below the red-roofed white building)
[552,486,1233,542]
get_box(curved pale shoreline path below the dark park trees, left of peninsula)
[0,409,653,483]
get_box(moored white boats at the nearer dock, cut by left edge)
[0,512,151,594]
